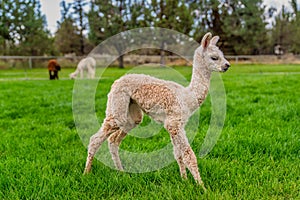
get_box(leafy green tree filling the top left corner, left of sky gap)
[0,0,53,55]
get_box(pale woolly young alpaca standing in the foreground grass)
[85,33,230,190]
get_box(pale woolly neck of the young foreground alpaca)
[188,52,211,106]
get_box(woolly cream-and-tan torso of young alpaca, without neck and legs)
[107,74,191,123]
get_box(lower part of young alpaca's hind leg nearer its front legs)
[108,130,126,171]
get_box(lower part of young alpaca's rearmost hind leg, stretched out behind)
[84,117,119,173]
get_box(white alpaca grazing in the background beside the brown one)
[70,57,96,79]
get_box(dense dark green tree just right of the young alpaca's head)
[217,0,268,54]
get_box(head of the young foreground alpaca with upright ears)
[195,33,230,72]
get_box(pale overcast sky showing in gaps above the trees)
[40,0,300,33]
